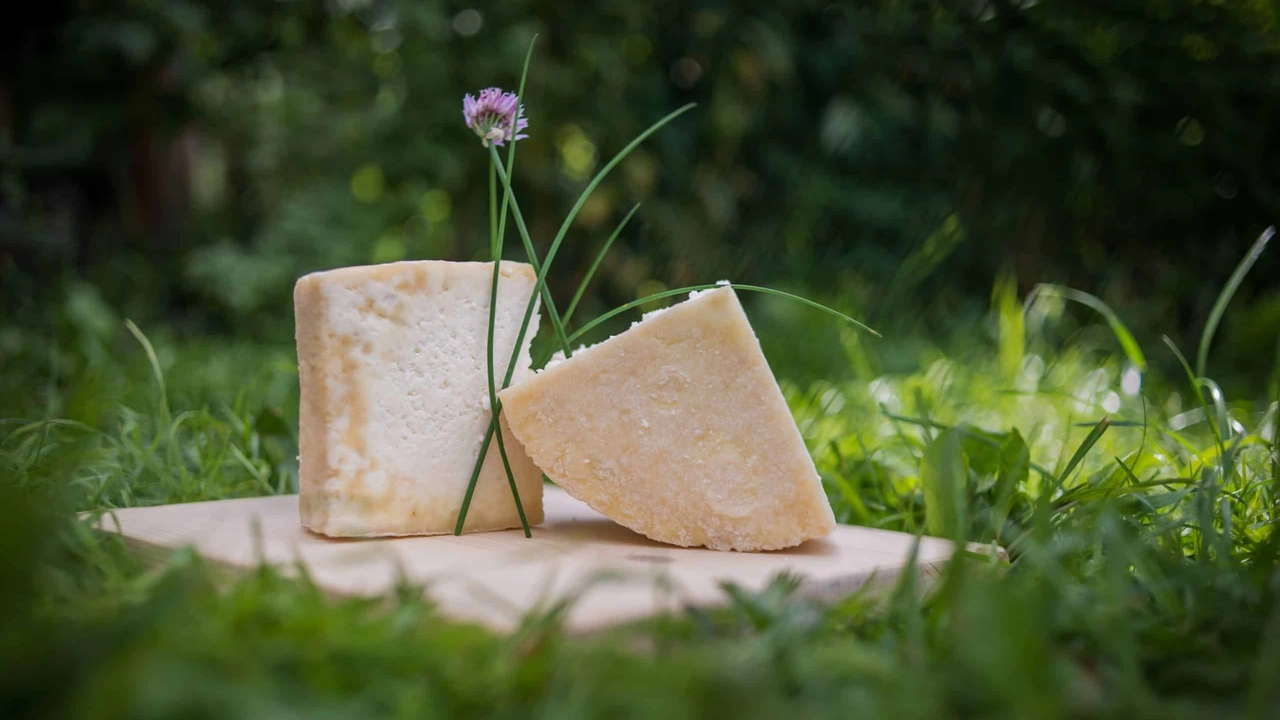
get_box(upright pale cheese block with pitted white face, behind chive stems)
[293,261,543,537]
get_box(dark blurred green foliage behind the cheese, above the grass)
[0,0,1280,397]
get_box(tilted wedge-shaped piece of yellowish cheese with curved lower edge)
[500,287,836,550]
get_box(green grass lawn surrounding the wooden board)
[0,265,1280,719]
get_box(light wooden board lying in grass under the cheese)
[94,487,983,630]
